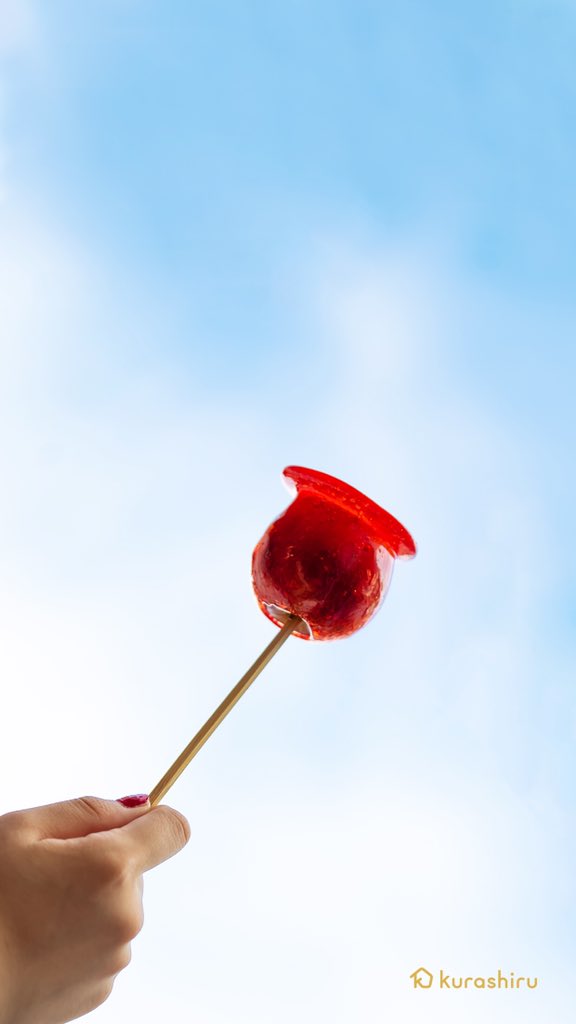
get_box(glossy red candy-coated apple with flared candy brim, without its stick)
[252,466,416,640]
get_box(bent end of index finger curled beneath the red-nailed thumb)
[119,804,191,874]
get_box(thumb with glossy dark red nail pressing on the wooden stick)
[18,797,150,839]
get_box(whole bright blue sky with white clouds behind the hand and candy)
[0,0,576,1024]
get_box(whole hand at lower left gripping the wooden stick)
[0,797,190,1024]
